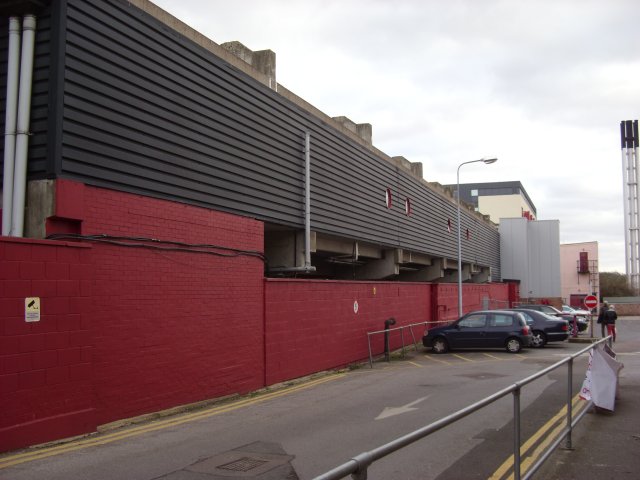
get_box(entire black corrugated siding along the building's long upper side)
[1,0,499,279]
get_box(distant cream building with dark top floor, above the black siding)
[447,182,538,223]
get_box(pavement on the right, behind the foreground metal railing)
[534,317,640,480]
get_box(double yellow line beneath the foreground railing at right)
[489,395,587,480]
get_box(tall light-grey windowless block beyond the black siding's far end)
[500,218,561,302]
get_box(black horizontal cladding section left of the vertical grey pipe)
[62,1,303,225]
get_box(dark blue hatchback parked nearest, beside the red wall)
[422,310,532,353]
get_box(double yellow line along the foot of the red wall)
[0,373,346,469]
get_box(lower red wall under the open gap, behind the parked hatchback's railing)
[265,280,431,384]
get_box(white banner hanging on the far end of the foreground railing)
[580,344,624,411]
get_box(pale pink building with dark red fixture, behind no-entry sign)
[560,242,600,308]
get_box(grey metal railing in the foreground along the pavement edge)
[314,336,611,480]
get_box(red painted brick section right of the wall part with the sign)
[76,184,264,424]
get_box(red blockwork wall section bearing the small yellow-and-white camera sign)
[0,237,97,451]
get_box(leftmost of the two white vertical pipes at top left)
[2,17,20,236]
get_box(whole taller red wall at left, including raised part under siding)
[0,181,264,451]
